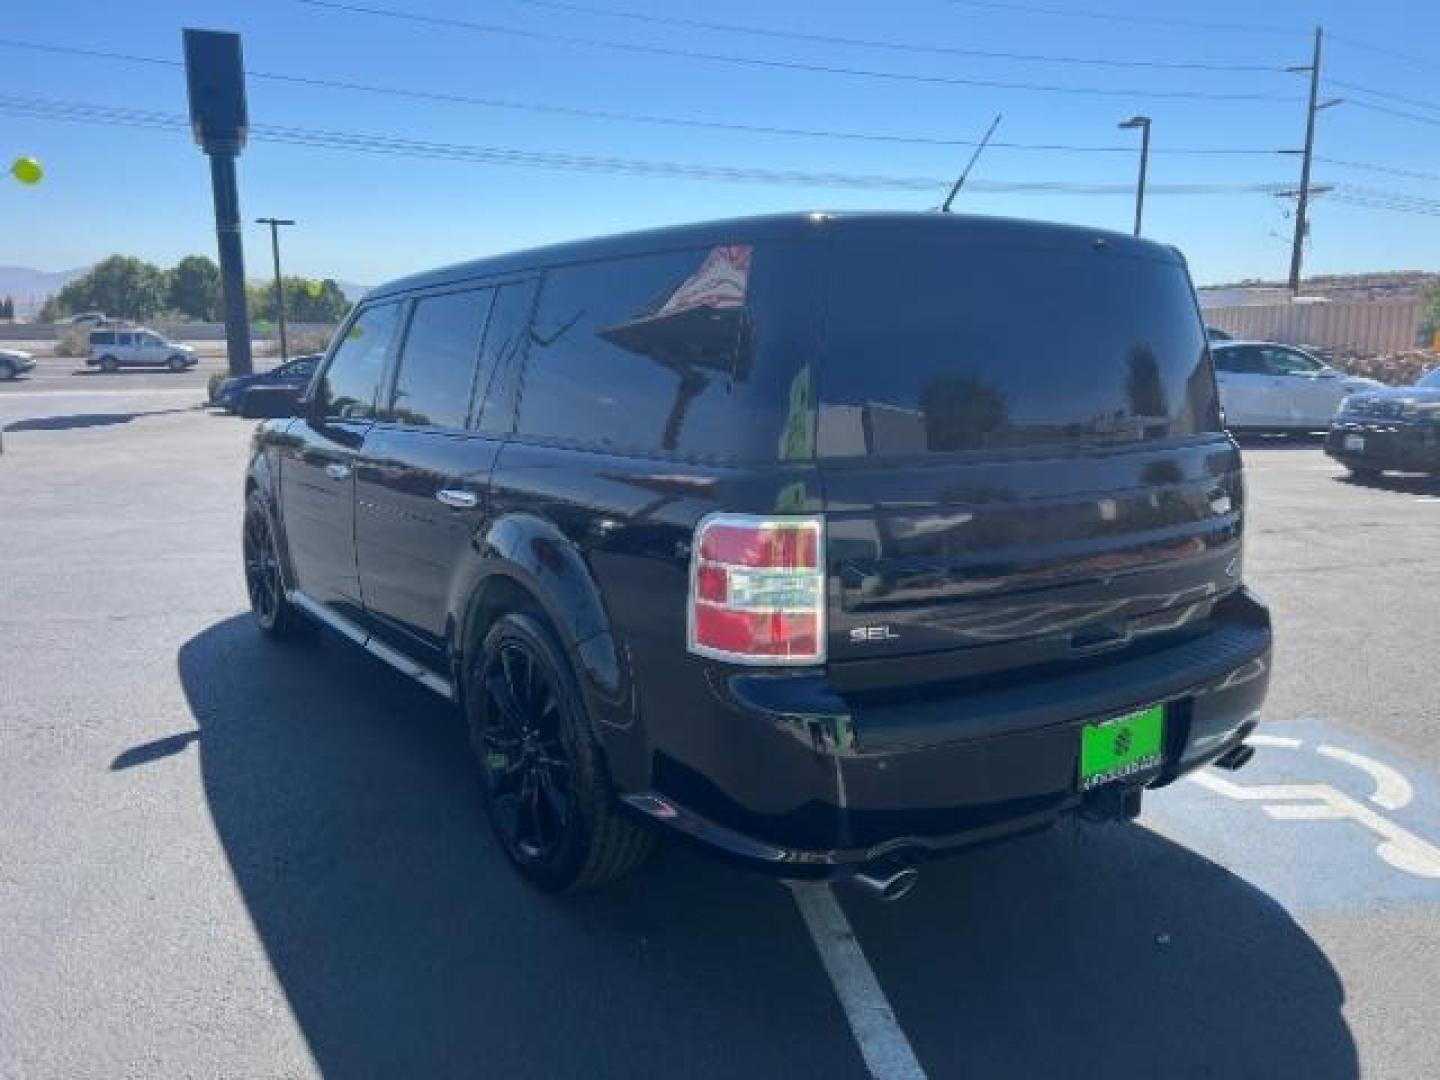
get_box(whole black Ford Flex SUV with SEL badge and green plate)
[245,213,1270,893]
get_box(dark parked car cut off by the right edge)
[1325,367,1440,477]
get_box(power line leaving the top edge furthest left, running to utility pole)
[286,0,1299,104]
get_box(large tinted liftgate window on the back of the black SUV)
[816,236,1220,456]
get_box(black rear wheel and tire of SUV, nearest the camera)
[465,612,654,891]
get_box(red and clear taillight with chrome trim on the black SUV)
[688,514,825,664]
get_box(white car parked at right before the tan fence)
[1210,341,1384,432]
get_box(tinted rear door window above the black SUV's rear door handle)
[387,289,495,428]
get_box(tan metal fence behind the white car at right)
[1204,300,1420,356]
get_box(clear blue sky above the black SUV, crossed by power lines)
[0,0,1440,284]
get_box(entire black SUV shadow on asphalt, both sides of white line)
[174,616,1356,1080]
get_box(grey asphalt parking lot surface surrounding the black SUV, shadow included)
[0,385,1440,1079]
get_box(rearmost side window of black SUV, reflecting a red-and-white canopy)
[517,242,818,461]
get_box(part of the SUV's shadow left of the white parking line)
[177,615,864,1080]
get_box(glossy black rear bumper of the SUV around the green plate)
[624,592,1270,878]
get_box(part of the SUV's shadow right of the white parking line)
[845,812,1359,1080]
